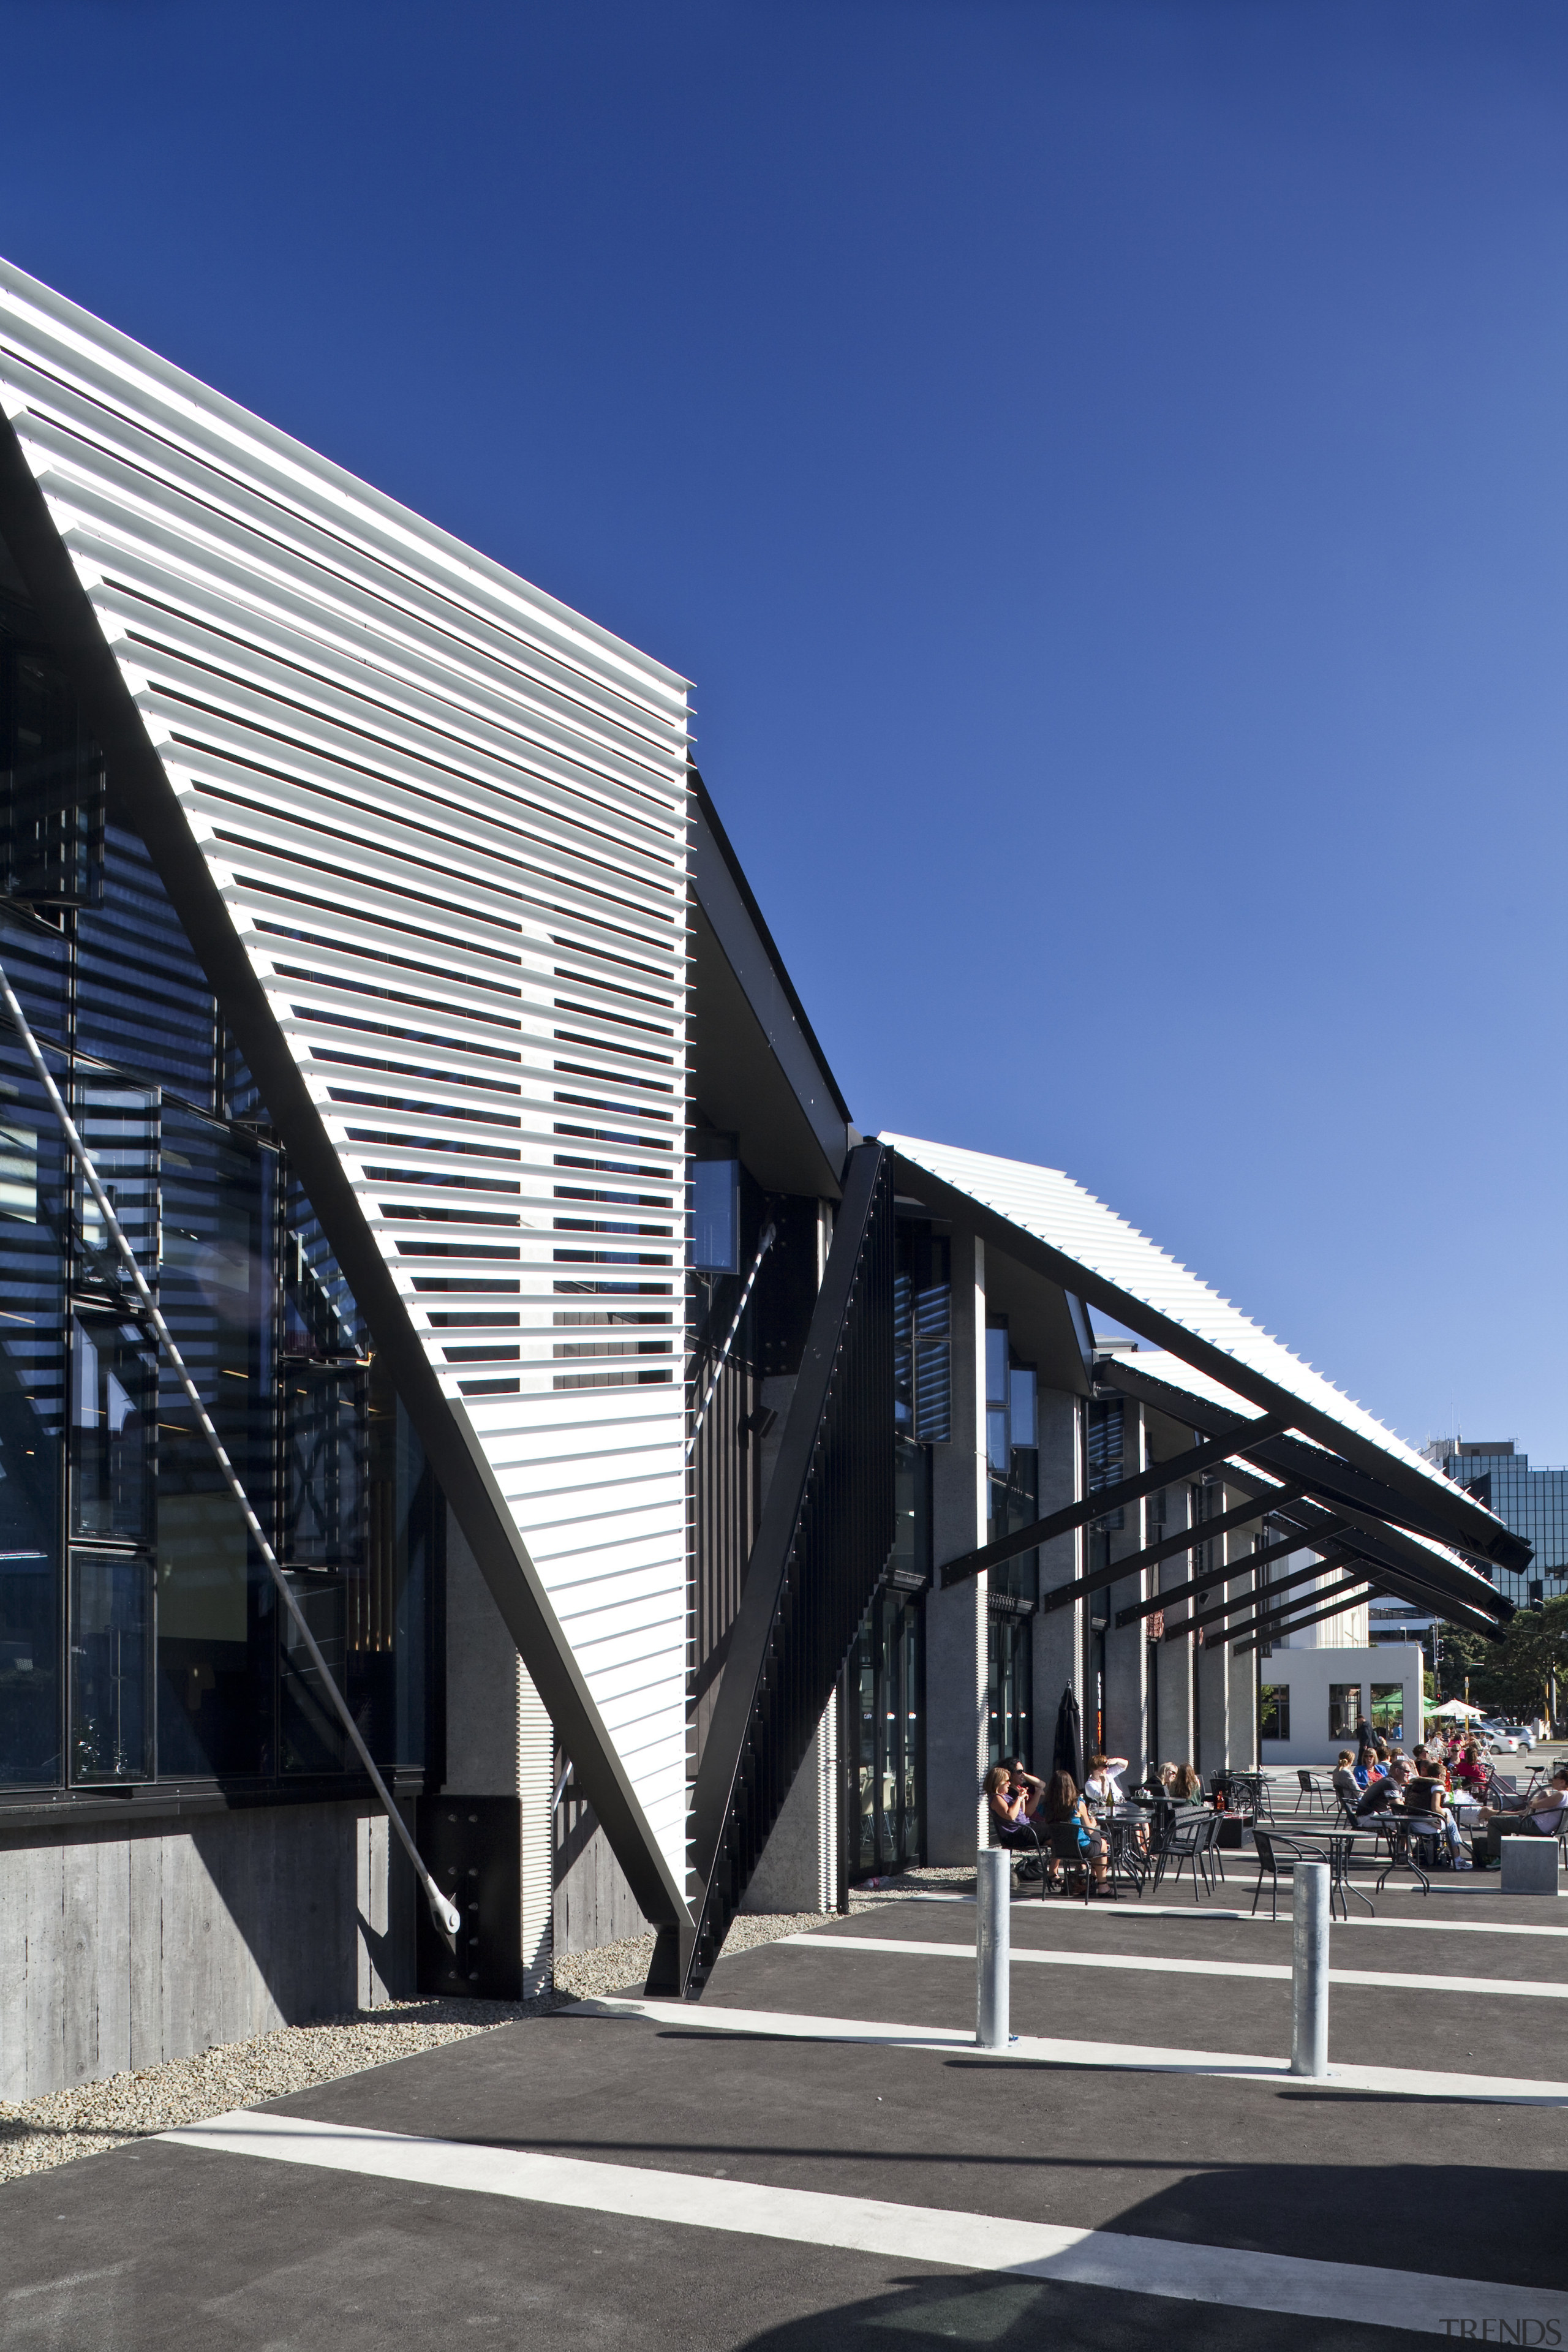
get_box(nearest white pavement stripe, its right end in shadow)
[160,2109,1568,2335]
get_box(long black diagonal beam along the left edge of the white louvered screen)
[0,419,689,1929]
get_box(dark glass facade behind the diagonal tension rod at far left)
[0,555,442,1792]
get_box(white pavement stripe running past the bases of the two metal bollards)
[582,1997,1568,2108]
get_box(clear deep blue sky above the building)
[0,0,1568,1463]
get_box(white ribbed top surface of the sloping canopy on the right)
[881,1134,1507,1571]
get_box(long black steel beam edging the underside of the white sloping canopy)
[898,1157,1531,1569]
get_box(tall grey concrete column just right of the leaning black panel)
[926,1232,987,1865]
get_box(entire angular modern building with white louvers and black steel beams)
[0,266,1528,2098]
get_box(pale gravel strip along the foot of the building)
[0,1912,846,2180]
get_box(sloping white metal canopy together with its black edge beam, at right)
[881,1134,1526,1566]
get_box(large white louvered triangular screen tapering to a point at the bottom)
[0,252,687,1882]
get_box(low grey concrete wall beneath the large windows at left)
[0,1804,416,2100]
